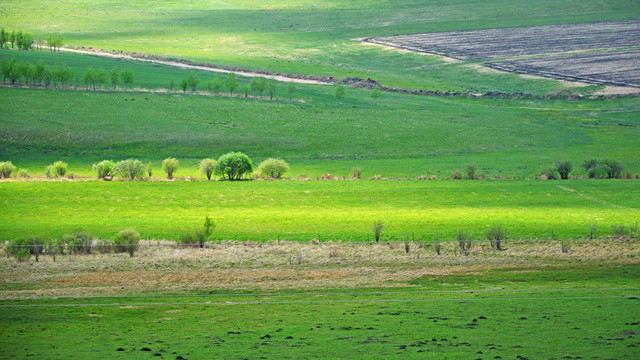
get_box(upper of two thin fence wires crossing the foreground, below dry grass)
[0,288,640,301]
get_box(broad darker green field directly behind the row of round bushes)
[0,86,640,179]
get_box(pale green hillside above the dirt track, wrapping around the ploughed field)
[5,0,640,94]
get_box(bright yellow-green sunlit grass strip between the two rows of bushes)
[0,180,640,241]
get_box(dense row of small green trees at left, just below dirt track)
[0,58,134,90]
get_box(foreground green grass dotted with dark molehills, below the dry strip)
[0,266,640,359]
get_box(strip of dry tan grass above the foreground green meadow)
[0,240,640,297]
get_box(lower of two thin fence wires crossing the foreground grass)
[0,295,638,308]
